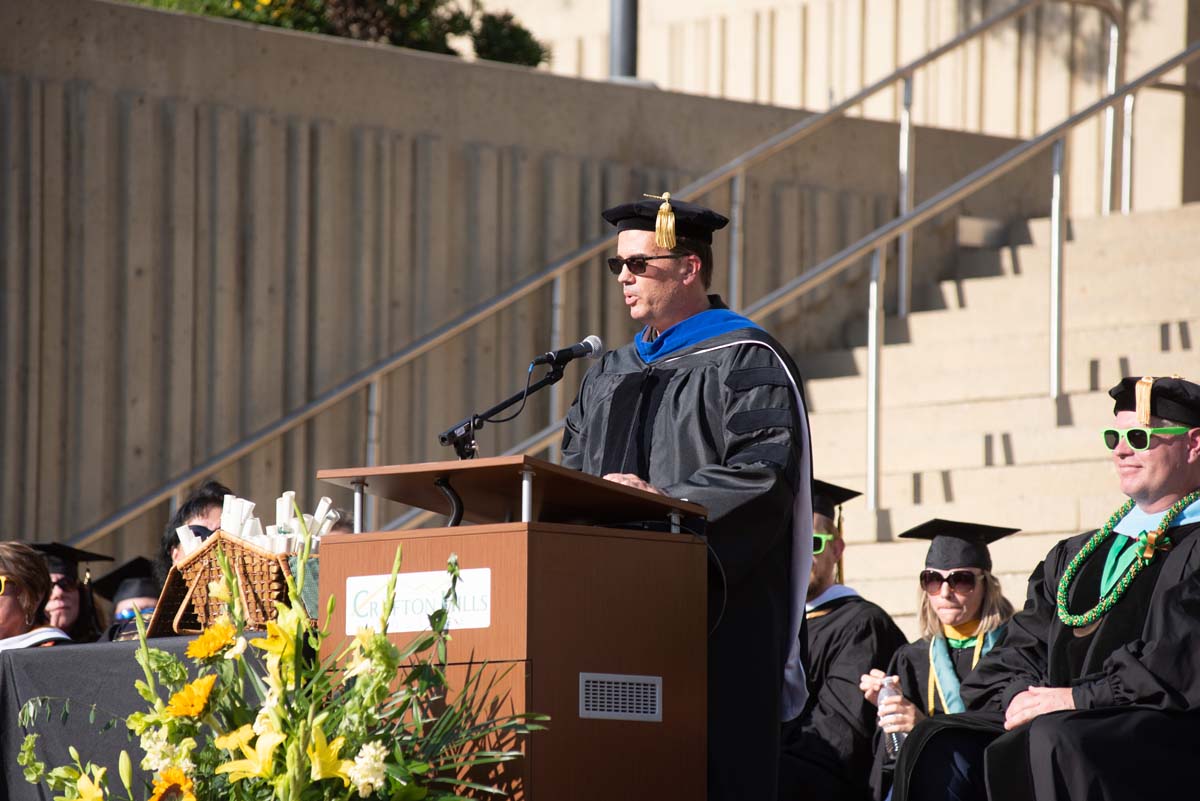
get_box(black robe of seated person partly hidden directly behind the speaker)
[779,596,906,801]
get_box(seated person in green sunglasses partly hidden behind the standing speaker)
[779,481,907,801]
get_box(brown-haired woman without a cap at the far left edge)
[0,542,71,651]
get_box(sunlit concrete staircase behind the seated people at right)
[799,204,1200,637]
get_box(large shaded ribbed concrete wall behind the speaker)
[0,0,1049,556]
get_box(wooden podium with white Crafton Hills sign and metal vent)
[317,456,707,801]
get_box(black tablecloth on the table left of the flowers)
[0,637,191,801]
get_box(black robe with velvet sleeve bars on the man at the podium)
[563,309,812,801]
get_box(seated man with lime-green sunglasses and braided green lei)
[896,377,1200,801]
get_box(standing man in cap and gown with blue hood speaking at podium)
[563,195,812,801]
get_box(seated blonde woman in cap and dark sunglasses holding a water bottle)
[859,519,1018,799]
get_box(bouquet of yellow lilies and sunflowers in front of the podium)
[19,496,546,801]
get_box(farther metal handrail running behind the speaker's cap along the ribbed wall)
[70,0,1128,547]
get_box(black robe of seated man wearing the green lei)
[896,524,1200,801]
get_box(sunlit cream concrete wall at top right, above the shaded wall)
[494,0,1200,216]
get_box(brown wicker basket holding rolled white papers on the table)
[148,531,292,637]
